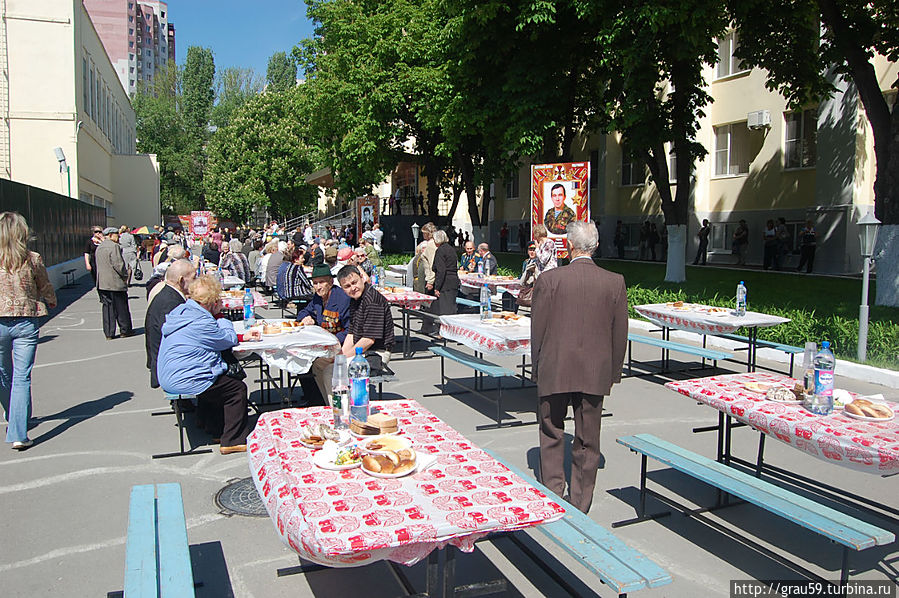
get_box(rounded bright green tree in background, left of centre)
[204,87,318,222]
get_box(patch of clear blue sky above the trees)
[168,0,312,78]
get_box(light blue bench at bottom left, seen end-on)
[125,484,194,598]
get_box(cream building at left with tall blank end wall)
[0,0,160,226]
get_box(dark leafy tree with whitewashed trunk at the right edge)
[728,0,899,305]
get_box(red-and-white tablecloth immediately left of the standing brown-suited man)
[440,314,531,355]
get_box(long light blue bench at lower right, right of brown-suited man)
[612,434,896,584]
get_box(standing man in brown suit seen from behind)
[531,222,627,513]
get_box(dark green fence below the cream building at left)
[0,179,106,266]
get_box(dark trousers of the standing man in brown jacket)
[540,392,603,513]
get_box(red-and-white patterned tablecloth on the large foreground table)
[247,400,564,568]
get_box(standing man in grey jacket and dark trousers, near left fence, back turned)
[94,226,134,340]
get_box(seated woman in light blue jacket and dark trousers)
[156,275,258,455]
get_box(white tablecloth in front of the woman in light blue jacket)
[233,319,340,375]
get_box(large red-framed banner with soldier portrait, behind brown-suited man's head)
[531,162,590,258]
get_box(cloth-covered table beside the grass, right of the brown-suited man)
[634,303,790,372]
